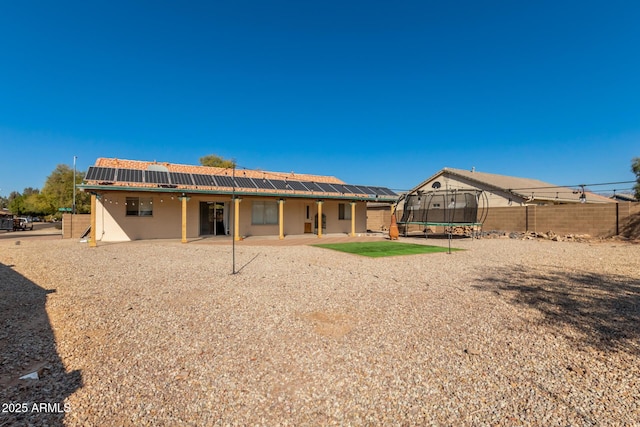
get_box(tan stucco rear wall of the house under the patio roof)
[96,192,367,242]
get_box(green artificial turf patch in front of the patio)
[312,240,460,258]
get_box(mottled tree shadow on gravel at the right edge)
[475,267,640,354]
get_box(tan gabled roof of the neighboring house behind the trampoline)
[412,168,612,203]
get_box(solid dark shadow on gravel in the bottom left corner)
[0,263,82,426]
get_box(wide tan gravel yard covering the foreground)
[0,239,640,426]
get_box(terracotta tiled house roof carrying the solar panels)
[80,158,398,202]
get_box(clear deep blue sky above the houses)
[0,0,640,196]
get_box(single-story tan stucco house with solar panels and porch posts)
[80,159,397,244]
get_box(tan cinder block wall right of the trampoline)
[482,202,640,237]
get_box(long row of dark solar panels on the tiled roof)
[85,166,398,197]
